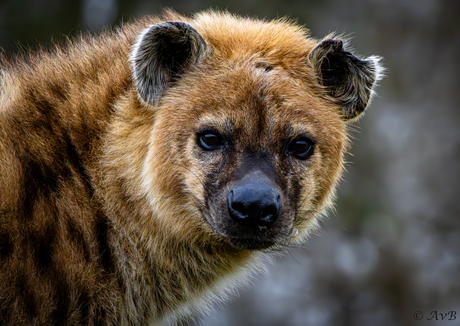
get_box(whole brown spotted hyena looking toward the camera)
[0,11,382,325]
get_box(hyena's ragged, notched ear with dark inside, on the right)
[308,39,384,120]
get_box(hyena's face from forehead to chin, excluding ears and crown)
[158,69,345,249]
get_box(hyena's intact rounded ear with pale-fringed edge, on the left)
[130,22,208,105]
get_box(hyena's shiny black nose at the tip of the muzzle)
[228,176,281,226]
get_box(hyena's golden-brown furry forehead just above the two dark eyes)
[160,62,342,143]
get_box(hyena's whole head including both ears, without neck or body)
[127,13,381,250]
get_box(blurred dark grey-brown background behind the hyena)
[0,0,460,326]
